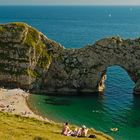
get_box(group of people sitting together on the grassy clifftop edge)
[61,122,88,137]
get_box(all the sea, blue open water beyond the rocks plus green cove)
[0,6,140,140]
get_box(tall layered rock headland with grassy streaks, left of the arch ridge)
[0,23,63,89]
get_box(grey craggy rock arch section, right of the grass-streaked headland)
[44,37,140,94]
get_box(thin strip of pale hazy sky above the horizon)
[0,0,140,5]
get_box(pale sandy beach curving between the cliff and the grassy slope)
[0,88,49,121]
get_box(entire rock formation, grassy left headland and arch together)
[0,23,140,94]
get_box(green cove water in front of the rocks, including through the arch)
[29,66,140,140]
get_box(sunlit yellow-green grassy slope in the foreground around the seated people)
[0,112,112,140]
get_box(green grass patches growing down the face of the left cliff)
[24,25,52,78]
